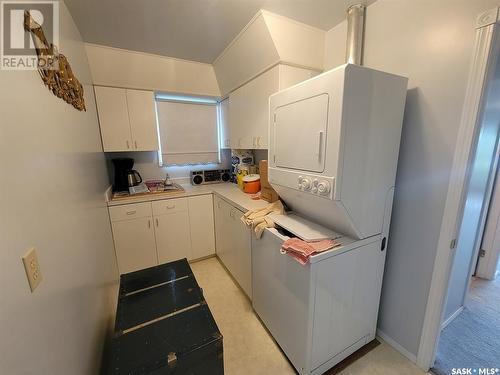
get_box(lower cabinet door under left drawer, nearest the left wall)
[112,217,158,274]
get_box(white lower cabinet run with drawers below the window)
[109,194,215,274]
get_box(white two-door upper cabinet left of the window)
[94,86,158,152]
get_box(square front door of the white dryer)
[273,94,329,173]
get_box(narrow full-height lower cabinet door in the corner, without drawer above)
[188,194,215,259]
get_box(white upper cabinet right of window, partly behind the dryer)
[229,65,314,149]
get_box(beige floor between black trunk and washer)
[191,258,424,375]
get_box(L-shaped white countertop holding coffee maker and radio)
[108,182,269,212]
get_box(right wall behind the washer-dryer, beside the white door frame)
[325,0,500,357]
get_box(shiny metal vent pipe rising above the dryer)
[346,4,365,65]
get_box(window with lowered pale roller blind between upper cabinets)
[156,93,220,165]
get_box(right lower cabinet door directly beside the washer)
[230,208,252,299]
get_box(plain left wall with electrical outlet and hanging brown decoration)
[0,2,118,375]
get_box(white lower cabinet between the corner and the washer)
[214,197,252,299]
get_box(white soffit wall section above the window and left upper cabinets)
[85,44,220,96]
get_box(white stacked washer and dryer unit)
[252,64,408,374]
